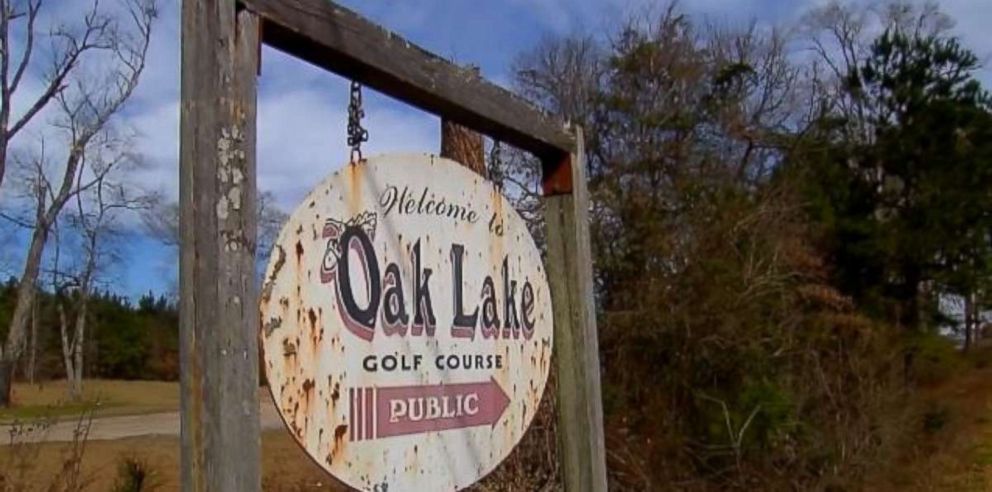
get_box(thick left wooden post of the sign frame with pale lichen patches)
[180,0,261,492]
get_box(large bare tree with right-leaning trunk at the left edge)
[0,0,157,406]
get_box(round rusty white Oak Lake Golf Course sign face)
[260,155,552,492]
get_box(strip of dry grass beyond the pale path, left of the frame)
[0,379,179,421]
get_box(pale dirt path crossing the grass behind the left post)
[0,395,283,442]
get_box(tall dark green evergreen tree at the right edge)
[799,30,992,332]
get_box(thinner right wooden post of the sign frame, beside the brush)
[544,128,606,492]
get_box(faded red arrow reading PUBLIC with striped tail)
[354,378,510,439]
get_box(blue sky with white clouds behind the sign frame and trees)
[0,0,992,295]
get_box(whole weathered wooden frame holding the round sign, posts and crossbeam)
[180,0,606,492]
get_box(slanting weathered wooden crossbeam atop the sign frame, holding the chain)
[239,0,574,167]
